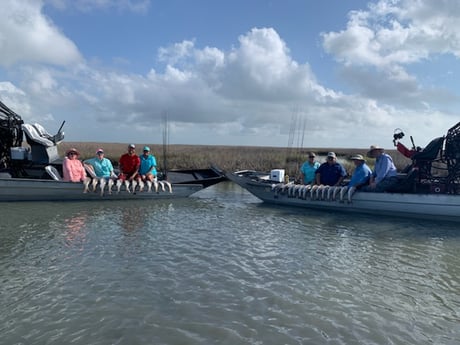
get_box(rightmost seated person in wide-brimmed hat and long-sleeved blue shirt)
[363,145,398,193]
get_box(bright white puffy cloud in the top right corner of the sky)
[322,0,460,68]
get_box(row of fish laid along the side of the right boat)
[272,182,356,203]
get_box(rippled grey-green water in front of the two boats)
[0,183,460,344]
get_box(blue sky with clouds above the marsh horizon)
[0,0,460,148]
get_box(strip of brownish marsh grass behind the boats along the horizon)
[59,142,410,176]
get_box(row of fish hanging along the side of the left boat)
[83,177,172,196]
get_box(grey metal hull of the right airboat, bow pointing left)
[226,174,460,222]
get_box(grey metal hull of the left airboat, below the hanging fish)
[0,178,203,202]
